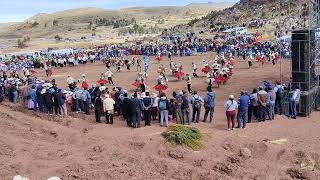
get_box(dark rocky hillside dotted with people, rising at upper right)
[166,0,306,38]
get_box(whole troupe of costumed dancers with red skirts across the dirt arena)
[39,45,279,93]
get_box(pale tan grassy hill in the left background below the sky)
[0,3,233,38]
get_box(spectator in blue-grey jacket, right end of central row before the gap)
[203,88,216,123]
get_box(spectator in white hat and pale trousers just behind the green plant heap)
[158,94,170,127]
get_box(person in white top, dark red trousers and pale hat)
[224,95,238,131]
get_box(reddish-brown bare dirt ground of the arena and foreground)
[0,54,320,180]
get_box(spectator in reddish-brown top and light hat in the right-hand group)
[258,87,268,122]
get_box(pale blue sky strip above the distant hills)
[0,0,236,23]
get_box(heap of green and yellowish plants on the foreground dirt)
[162,124,204,150]
